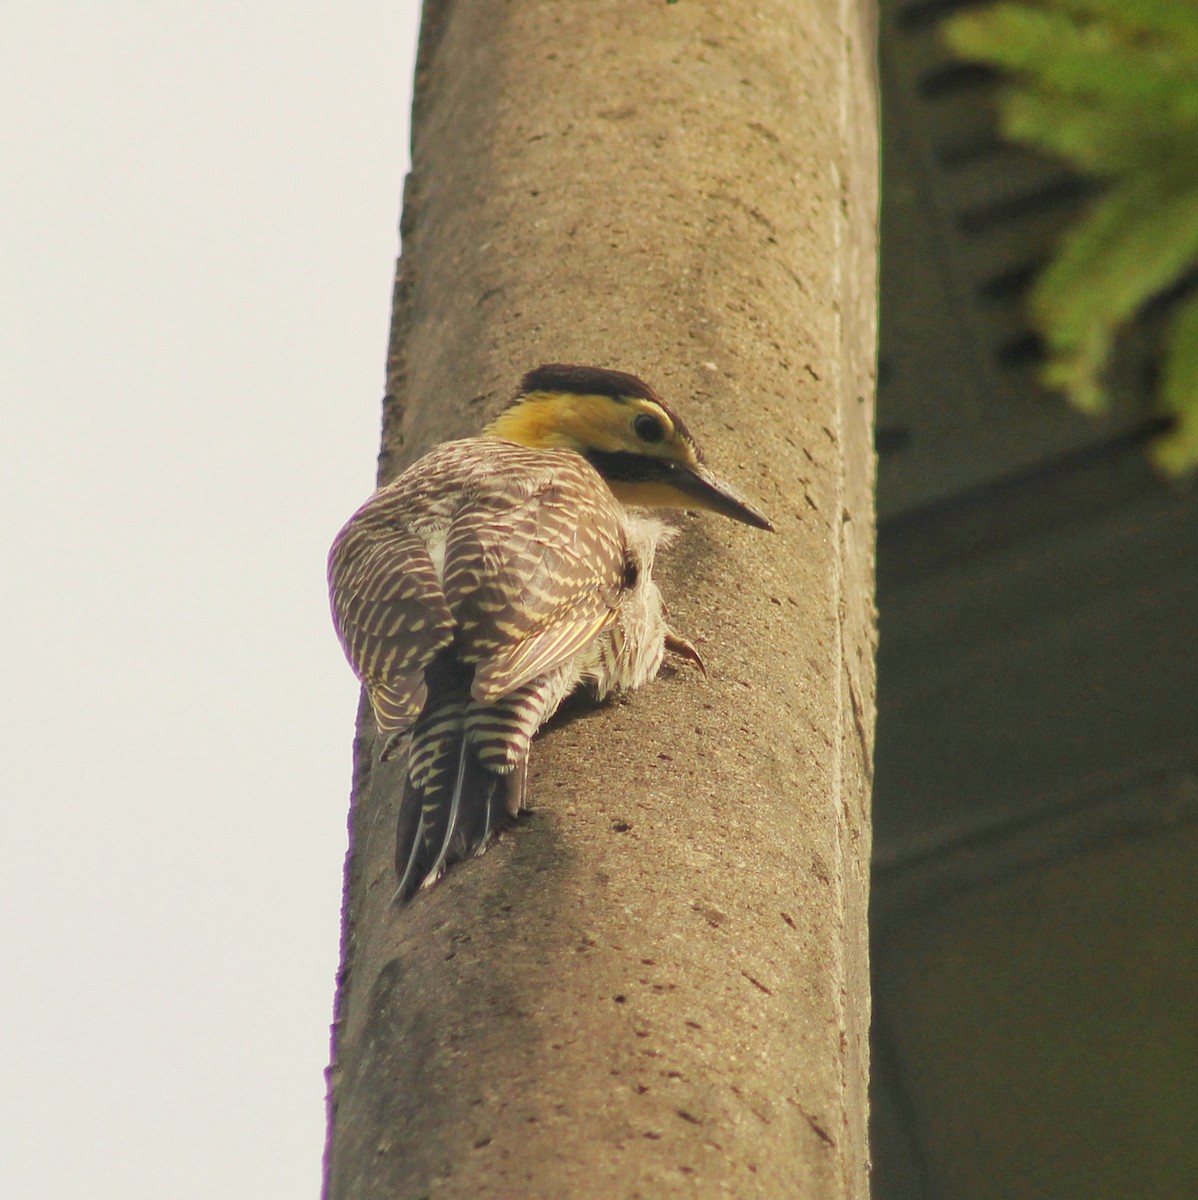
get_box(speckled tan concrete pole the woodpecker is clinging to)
[328,0,876,1200]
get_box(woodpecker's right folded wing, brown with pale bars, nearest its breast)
[444,458,625,701]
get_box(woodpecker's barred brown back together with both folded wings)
[329,438,627,732]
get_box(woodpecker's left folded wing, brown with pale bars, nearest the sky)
[329,506,454,733]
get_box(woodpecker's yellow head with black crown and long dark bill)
[485,362,773,529]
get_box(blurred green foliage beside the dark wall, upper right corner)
[947,0,1198,475]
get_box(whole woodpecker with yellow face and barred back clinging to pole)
[329,364,773,899]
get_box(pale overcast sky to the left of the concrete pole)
[0,0,419,1200]
